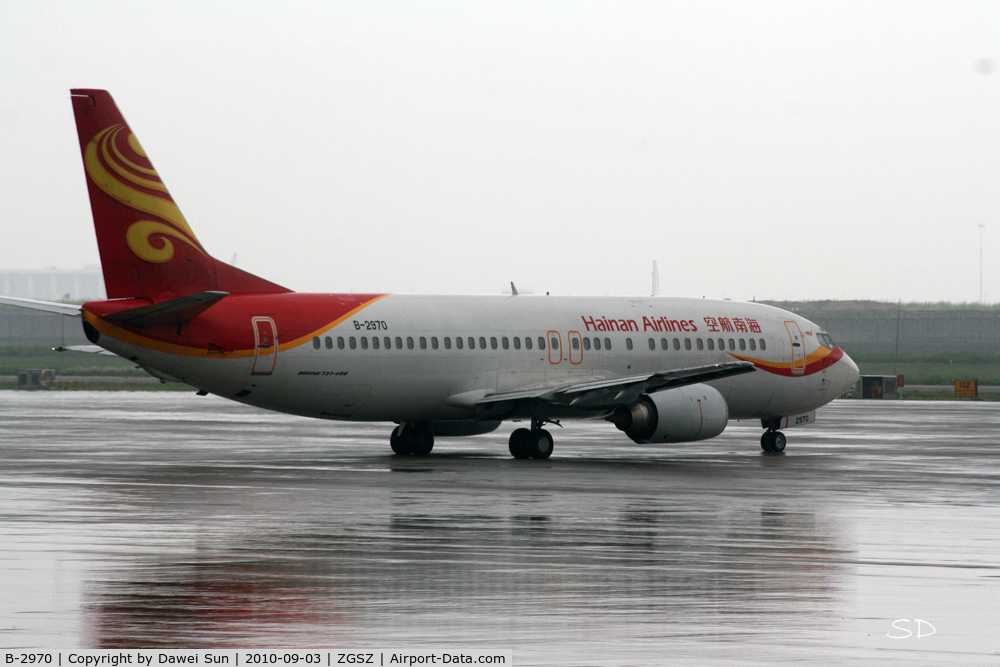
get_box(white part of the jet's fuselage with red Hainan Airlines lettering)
[94,295,857,422]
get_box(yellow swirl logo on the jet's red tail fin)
[83,124,206,264]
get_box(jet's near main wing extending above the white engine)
[475,361,754,410]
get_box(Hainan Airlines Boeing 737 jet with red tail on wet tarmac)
[0,89,858,460]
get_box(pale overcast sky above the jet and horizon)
[0,0,1000,302]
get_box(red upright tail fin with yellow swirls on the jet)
[70,89,290,299]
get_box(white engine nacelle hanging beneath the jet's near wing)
[608,384,729,442]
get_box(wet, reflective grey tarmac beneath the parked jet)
[0,391,1000,665]
